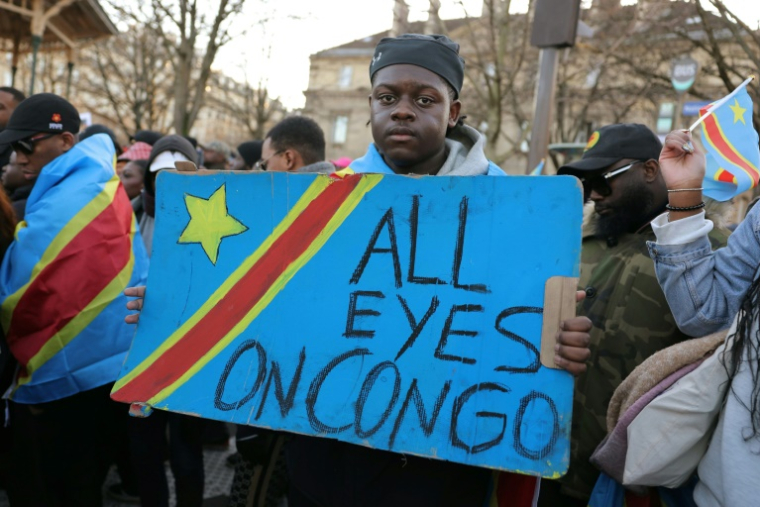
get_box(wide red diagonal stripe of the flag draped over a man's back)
[6,189,132,365]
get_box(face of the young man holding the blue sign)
[369,64,461,174]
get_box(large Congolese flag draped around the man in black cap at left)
[0,134,148,403]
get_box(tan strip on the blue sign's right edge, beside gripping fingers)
[541,276,578,369]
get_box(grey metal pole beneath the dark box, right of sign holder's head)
[525,47,559,174]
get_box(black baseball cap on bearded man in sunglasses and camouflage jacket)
[557,123,662,175]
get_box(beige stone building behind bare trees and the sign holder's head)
[303,0,748,174]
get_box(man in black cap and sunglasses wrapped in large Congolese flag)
[0,93,148,507]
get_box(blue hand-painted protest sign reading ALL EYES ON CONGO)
[113,172,582,477]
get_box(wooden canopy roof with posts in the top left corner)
[0,0,118,95]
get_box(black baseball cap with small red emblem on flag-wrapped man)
[0,93,81,145]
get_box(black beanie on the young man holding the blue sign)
[369,33,464,98]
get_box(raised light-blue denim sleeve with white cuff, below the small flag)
[648,206,760,336]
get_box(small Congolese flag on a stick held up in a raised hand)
[700,78,760,201]
